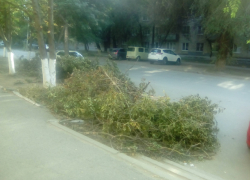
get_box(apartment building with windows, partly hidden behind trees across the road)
[144,19,250,59]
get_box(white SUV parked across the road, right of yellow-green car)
[148,48,181,65]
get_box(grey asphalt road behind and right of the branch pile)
[101,60,250,180]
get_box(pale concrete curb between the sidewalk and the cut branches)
[47,119,223,180]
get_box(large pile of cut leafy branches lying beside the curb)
[21,56,221,159]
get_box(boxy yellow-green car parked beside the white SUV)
[127,46,148,61]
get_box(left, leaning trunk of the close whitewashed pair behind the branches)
[32,0,51,88]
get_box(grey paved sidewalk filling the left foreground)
[0,88,154,180]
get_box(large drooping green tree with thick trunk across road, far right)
[193,0,250,67]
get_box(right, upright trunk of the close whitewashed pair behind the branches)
[48,0,56,87]
